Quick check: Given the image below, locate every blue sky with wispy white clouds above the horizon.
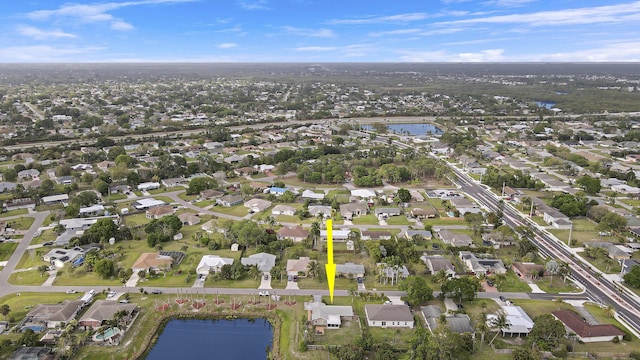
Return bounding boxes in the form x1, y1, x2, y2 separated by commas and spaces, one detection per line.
0, 0, 640, 62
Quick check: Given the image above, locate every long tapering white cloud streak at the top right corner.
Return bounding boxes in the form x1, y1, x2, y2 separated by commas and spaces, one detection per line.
440, 2, 640, 26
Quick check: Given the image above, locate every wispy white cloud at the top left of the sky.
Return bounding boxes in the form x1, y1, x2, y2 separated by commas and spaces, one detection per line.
25, 0, 195, 30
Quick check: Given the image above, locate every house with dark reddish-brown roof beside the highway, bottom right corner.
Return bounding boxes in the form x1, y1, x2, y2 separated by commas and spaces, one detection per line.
551, 310, 624, 342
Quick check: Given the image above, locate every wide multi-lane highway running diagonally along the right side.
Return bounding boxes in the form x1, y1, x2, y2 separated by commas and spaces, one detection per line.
449, 164, 640, 334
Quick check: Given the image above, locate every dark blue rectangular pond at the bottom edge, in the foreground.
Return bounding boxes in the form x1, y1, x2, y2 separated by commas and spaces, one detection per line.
147, 319, 273, 360
